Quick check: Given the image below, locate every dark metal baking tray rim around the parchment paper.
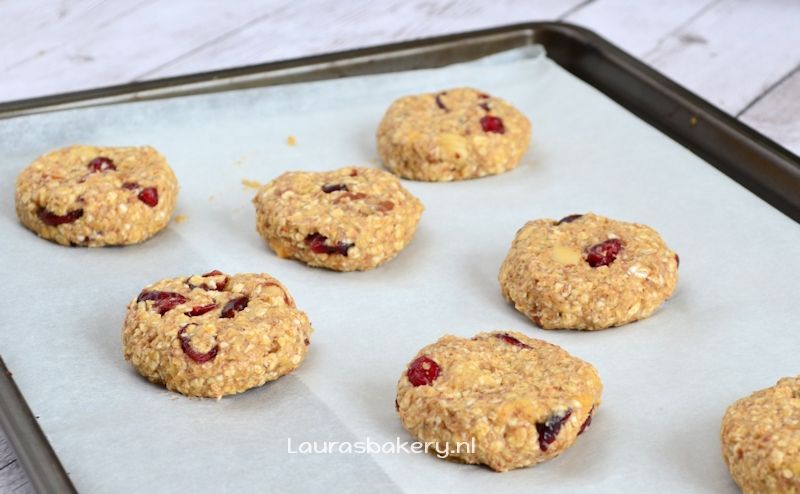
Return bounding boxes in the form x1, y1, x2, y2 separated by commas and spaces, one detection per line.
0, 23, 800, 492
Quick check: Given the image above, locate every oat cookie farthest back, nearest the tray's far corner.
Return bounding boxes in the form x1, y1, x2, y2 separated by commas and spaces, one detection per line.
378, 88, 531, 182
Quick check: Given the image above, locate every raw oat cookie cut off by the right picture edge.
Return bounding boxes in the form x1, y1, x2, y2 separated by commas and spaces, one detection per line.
721, 376, 800, 494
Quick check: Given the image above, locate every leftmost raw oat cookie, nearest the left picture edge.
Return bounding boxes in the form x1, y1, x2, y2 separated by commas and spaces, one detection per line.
15, 146, 178, 247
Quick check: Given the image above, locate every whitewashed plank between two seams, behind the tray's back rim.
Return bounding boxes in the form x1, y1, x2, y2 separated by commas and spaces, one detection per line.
140, 0, 581, 78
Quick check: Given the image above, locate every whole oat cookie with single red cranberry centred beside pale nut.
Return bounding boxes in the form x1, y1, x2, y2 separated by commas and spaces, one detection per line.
500, 213, 680, 330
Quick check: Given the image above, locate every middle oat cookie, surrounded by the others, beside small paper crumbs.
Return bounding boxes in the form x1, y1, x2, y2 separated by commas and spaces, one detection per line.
253, 167, 424, 271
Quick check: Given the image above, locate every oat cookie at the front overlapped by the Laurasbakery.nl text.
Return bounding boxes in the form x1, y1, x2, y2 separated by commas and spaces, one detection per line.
396, 331, 603, 472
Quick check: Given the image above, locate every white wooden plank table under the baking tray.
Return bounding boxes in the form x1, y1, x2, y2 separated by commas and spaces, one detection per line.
0, 0, 800, 493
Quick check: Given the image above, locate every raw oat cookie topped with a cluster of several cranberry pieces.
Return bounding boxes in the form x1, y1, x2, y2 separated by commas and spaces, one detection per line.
122, 271, 312, 398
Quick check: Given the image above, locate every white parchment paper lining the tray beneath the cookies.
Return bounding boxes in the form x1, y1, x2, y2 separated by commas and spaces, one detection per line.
0, 45, 800, 493
